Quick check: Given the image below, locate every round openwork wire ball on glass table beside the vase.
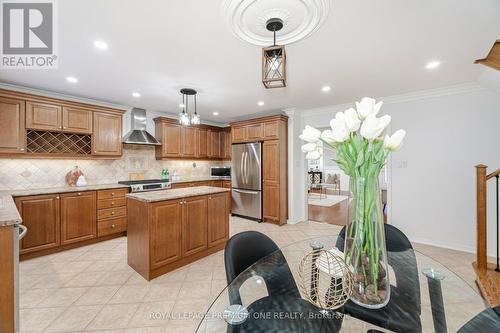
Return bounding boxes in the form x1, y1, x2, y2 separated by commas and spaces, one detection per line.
299, 249, 354, 309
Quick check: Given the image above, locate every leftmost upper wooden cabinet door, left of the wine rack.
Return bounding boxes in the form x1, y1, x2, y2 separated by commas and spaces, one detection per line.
0, 97, 26, 154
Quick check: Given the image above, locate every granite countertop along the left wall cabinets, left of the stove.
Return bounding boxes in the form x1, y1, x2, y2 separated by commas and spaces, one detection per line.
0, 183, 129, 227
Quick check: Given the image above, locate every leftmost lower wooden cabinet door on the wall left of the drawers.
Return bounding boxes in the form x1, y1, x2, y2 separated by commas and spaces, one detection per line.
15, 194, 61, 254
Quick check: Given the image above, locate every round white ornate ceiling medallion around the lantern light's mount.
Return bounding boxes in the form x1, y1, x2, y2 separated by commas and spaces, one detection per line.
222, 0, 331, 46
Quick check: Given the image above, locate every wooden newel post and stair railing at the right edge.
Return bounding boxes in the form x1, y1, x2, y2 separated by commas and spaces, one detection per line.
476, 164, 500, 272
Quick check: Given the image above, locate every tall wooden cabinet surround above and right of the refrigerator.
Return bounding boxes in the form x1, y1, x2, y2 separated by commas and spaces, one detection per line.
230, 115, 288, 225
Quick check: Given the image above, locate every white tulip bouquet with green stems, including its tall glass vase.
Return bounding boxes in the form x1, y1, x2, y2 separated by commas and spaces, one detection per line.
300, 97, 406, 308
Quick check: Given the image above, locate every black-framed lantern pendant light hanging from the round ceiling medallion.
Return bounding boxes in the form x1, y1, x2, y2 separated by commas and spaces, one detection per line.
262, 18, 286, 89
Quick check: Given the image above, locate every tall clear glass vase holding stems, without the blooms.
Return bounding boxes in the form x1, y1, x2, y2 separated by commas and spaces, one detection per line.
344, 174, 390, 309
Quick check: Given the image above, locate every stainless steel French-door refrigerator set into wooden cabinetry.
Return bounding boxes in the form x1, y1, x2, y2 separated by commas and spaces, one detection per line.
231, 142, 262, 222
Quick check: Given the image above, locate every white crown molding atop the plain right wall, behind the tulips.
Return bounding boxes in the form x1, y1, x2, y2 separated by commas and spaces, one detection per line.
300, 82, 487, 118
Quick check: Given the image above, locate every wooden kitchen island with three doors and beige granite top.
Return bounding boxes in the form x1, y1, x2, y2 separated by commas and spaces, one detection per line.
127, 186, 231, 281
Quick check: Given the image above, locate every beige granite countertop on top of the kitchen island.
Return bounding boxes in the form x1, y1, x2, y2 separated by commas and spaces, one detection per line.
127, 186, 230, 202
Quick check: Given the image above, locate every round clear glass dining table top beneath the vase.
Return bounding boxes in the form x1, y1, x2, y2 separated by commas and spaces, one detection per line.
196, 235, 486, 333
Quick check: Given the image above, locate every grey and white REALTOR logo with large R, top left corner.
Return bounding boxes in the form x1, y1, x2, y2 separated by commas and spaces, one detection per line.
0, 0, 57, 69
